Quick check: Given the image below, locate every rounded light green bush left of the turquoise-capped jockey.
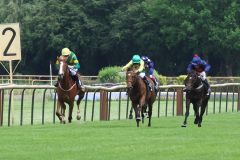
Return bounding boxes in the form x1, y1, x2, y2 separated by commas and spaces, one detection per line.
98, 66, 126, 83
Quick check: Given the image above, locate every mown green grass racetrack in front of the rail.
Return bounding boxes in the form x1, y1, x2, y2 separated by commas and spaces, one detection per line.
0, 112, 240, 160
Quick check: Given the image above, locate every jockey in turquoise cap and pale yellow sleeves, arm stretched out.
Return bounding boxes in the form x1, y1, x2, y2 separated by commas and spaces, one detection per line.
122, 55, 152, 90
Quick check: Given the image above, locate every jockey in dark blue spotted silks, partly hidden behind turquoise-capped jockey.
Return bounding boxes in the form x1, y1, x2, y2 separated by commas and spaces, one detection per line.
141, 56, 158, 89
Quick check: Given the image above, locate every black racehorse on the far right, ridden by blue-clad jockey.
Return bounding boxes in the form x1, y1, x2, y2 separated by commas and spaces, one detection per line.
182, 71, 210, 127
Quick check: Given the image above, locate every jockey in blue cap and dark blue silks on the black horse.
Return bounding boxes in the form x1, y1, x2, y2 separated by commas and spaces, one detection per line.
187, 54, 211, 95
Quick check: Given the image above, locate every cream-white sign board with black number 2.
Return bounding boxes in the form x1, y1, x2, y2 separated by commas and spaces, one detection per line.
0, 23, 21, 61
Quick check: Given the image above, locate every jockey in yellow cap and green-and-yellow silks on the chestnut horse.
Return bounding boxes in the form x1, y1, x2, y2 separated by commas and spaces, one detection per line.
55, 48, 84, 89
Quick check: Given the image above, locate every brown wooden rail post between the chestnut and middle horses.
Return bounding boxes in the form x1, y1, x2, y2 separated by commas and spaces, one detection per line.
100, 90, 108, 121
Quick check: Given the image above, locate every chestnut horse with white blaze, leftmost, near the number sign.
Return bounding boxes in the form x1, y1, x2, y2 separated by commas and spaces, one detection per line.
56, 56, 85, 123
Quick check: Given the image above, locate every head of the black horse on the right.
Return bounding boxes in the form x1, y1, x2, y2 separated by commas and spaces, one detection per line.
184, 71, 201, 91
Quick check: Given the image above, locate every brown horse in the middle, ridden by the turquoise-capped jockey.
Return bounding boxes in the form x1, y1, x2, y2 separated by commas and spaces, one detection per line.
126, 70, 156, 127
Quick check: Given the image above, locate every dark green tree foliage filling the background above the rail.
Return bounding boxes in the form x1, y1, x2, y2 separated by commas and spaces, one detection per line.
0, 0, 240, 76
